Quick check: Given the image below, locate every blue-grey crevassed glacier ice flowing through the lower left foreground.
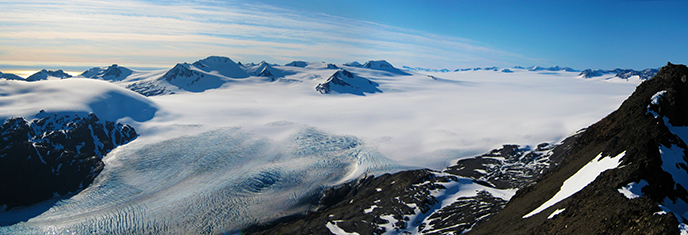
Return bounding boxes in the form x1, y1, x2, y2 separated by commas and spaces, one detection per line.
0, 127, 399, 234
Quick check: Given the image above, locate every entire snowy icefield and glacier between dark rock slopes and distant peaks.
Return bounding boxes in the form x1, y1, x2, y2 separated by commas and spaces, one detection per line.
0, 63, 640, 234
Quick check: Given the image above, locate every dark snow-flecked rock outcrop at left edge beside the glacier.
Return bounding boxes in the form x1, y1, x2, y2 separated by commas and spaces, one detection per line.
0, 112, 137, 208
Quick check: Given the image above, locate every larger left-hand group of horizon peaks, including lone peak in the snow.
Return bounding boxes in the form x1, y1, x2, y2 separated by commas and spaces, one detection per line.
0, 56, 410, 96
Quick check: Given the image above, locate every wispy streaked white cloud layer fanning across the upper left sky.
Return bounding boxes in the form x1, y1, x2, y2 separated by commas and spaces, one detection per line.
0, 0, 530, 68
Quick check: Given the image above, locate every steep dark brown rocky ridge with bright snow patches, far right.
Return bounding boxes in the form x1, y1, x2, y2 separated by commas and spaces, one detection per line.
470, 64, 688, 234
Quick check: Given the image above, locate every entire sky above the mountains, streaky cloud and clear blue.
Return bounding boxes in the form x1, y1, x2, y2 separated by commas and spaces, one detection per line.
0, 0, 688, 72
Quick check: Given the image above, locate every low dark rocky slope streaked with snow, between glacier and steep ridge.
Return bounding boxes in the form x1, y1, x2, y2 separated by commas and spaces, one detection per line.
248, 134, 579, 234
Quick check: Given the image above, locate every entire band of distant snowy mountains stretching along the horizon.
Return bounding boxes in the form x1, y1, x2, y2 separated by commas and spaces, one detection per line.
0, 56, 658, 91
